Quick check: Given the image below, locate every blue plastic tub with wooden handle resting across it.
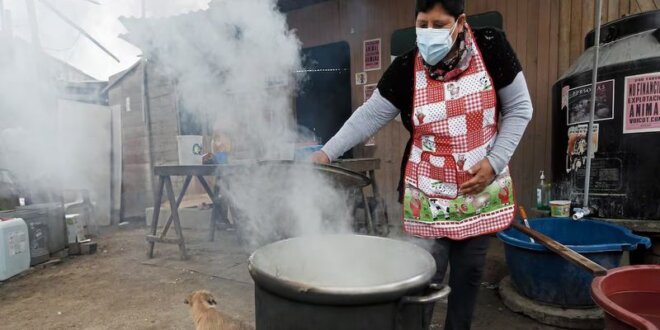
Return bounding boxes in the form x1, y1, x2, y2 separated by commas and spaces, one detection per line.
497, 218, 651, 307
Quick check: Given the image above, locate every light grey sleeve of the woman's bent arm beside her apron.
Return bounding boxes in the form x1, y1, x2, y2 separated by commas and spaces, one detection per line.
487, 71, 533, 174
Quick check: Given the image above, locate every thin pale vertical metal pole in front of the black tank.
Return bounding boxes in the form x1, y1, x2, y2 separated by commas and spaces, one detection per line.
584, 0, 600, 209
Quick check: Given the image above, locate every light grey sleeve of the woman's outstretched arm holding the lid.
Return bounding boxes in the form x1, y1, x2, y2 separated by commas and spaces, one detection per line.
321, 89, 399, 161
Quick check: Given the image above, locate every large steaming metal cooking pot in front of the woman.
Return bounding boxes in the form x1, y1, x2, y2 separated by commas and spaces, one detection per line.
249, 235, 449, 330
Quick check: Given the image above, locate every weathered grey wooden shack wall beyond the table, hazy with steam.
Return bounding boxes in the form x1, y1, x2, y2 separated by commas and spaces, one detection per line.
108, 63, 182, 219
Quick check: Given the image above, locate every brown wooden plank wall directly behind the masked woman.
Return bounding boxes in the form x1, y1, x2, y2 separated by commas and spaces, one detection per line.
288, 0, 660, 222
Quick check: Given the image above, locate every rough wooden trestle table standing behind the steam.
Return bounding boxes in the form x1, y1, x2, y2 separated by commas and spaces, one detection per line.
146, 158, 387, 259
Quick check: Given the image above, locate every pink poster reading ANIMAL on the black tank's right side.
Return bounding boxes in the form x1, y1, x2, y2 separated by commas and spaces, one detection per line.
623, 72, 660, 134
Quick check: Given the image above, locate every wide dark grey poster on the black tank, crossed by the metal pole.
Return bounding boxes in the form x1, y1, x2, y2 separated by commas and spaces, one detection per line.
566, 79, 614, 125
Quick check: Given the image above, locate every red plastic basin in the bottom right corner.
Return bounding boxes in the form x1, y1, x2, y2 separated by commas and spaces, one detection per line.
591, 265, 660, 330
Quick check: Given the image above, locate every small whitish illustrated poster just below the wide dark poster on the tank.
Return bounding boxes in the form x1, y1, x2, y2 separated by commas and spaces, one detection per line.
566, 124, 599, 173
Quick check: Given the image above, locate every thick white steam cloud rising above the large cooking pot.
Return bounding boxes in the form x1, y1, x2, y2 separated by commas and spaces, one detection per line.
126, 0, 358, 248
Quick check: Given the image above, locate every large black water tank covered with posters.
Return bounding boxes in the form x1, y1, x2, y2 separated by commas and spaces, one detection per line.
552, 10, 660, 221
